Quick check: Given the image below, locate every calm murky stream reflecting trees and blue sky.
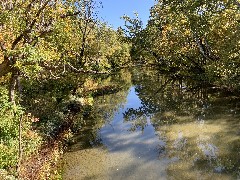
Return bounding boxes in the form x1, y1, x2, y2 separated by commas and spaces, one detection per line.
63, 68, 240, 180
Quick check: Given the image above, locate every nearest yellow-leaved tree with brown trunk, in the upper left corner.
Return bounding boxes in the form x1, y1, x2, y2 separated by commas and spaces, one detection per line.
0, 0, 86, 102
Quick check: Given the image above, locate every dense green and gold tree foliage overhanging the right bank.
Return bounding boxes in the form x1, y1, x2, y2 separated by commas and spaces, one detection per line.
127, 0, 240, 88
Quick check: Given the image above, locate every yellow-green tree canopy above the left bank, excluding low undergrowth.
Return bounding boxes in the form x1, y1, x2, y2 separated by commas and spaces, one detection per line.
0, 0, 129, 81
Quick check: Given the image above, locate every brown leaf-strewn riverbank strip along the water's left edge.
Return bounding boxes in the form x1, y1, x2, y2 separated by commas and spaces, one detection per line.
16, 84, 128, 180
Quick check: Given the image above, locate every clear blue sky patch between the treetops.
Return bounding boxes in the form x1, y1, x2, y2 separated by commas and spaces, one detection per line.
98, 0, 154, 29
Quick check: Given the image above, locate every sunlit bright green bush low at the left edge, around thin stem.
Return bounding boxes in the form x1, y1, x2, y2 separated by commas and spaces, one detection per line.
0, 87, 41, 172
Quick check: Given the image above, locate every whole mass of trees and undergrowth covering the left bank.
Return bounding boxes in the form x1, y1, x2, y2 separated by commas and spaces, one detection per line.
0, 0, 130, 177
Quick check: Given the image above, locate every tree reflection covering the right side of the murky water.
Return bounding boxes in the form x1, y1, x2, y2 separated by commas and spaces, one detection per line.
124, 67, 240, 179
